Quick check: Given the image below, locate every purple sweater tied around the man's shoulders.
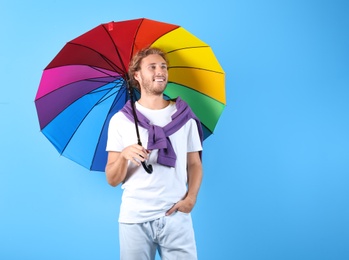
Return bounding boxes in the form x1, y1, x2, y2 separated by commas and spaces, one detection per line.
120, 97, 203, 167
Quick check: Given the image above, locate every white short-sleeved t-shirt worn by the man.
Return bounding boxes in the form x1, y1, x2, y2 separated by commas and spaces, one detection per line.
106, 102, 202, 223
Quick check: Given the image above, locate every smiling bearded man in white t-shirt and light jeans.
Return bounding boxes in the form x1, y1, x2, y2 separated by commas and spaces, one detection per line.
105, 48, 202, 260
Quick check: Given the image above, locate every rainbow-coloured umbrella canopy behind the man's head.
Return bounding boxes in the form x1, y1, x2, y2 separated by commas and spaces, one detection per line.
35, 18, 225, 171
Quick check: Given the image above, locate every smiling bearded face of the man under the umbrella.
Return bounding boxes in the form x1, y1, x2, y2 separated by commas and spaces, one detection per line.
135, 54, 168, 95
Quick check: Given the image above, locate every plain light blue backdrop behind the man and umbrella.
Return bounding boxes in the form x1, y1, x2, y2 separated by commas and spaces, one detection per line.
0, 0, 349, 260
